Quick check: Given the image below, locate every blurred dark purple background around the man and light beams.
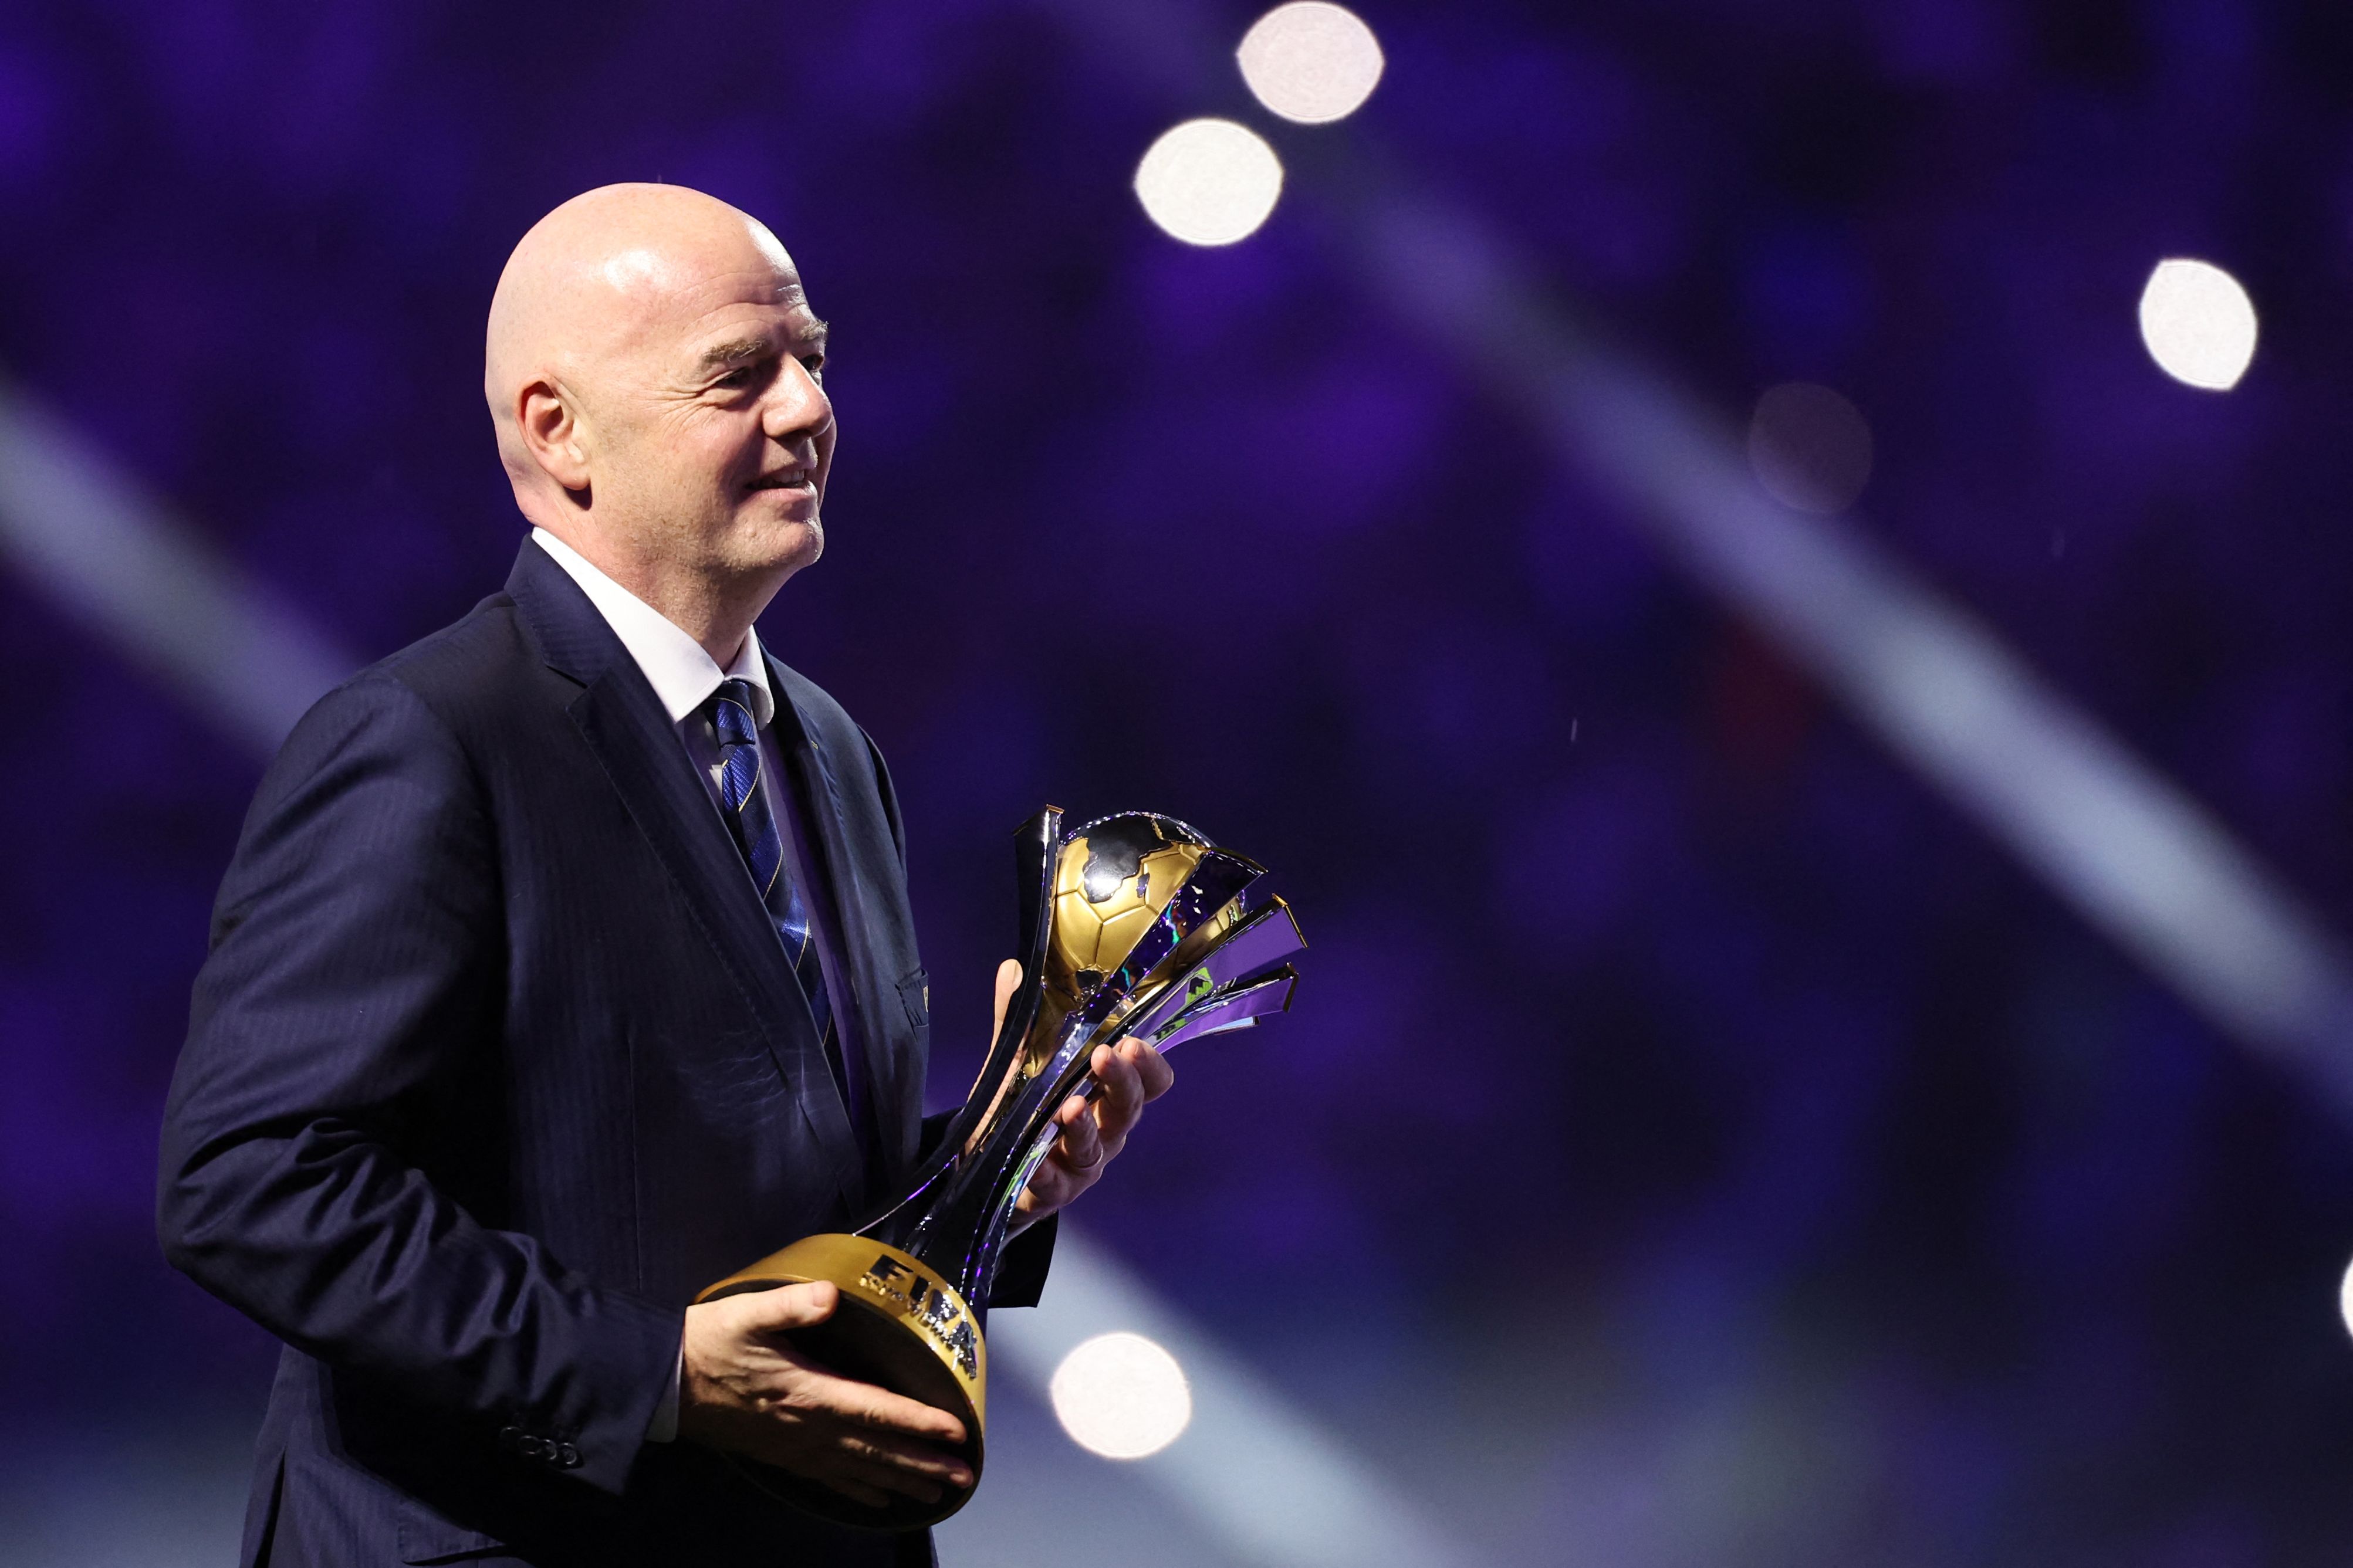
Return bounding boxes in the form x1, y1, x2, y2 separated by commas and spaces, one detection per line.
0, 0, 2353, 1568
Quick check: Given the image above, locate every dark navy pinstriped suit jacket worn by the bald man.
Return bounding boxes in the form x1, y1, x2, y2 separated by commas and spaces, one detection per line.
158, 543, 1052, 1568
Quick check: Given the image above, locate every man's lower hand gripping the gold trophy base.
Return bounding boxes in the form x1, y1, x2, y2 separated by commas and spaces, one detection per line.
678, 1281, 972, 1507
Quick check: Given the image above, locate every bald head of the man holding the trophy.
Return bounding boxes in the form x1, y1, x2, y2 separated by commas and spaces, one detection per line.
482, 186, 833, 663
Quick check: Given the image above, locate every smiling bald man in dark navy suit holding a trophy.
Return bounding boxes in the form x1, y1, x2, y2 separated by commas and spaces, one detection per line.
160, 186, 1169, 1568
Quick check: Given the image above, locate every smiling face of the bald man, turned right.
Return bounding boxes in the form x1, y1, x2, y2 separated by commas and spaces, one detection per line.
583, 231, 833, 594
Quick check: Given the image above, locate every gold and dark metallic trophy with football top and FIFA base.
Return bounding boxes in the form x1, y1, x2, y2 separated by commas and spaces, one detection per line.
697, 807, 1306, 1530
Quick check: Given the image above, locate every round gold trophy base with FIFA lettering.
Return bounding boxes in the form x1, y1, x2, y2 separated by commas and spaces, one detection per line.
694, 1234, 988, 1530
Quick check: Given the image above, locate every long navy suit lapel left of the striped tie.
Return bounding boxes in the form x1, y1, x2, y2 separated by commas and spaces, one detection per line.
506, 543, 864, 1206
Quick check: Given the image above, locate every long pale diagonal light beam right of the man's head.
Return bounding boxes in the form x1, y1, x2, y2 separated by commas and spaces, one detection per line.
1341, 181, 2353, 1105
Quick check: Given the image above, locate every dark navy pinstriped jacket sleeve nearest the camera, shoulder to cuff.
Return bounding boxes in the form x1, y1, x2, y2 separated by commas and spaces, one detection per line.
158, 675, 682, 1491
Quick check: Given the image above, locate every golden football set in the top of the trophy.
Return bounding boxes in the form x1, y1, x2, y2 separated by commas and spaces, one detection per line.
1044, 811, 1209, 1001
